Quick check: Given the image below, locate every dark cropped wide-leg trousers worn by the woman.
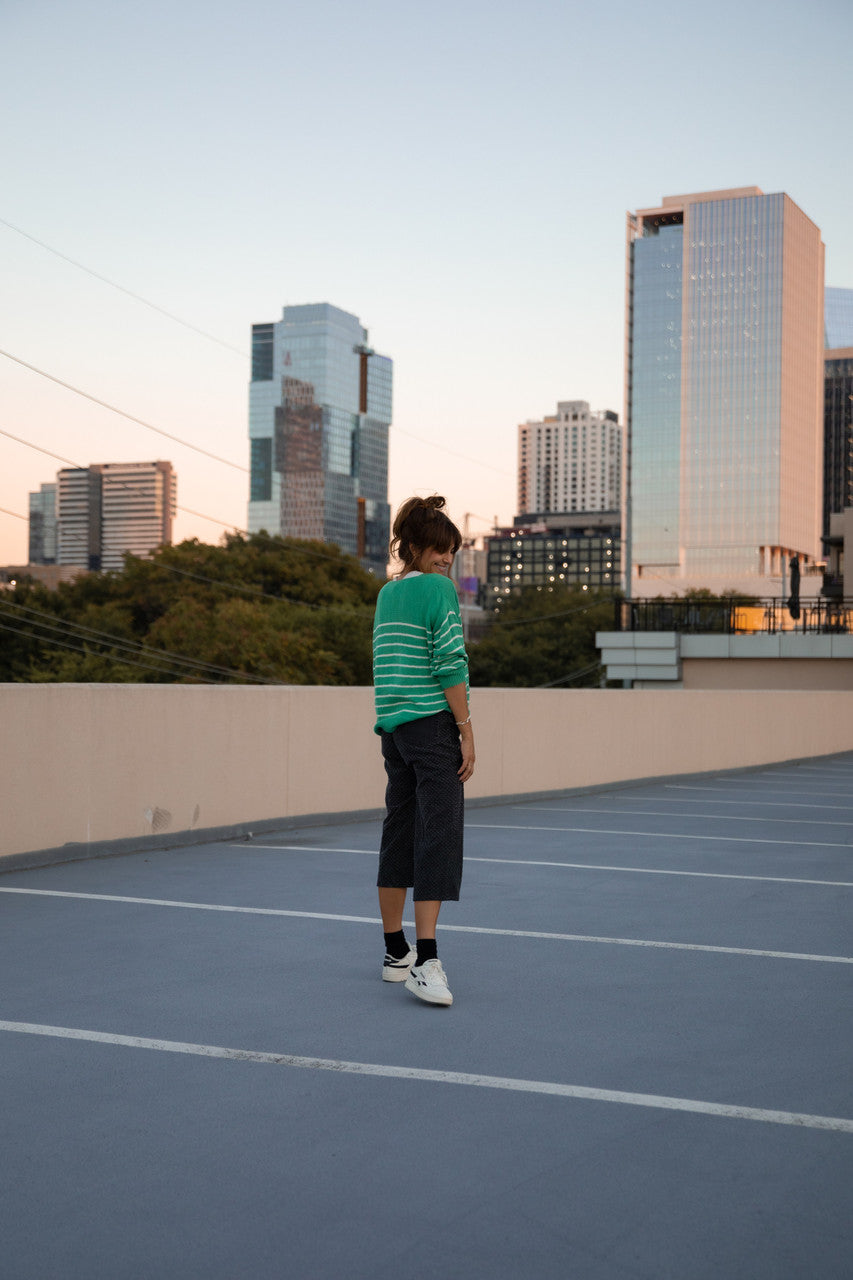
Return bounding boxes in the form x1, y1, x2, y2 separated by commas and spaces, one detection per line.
377, 712, 465, 902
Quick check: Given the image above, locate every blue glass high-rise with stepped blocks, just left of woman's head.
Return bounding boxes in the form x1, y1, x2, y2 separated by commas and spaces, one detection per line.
248, 303, 392, 576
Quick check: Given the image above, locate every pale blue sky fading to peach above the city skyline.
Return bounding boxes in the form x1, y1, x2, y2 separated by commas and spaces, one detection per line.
0, 0, 853, 564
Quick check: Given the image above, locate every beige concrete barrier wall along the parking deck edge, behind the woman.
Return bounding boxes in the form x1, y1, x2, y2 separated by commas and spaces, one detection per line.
0, 685, 853, 858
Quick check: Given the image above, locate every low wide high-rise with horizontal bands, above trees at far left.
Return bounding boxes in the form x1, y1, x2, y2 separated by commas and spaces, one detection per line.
56, 462, 177, 570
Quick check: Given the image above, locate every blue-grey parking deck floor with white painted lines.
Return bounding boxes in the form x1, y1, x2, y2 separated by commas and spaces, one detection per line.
0, 754, 853, 1280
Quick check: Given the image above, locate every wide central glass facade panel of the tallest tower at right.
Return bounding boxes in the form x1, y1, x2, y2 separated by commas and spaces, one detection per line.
681, 196, 783, 573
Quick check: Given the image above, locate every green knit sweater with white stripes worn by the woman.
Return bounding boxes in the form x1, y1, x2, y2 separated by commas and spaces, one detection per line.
373, 573, 467, 733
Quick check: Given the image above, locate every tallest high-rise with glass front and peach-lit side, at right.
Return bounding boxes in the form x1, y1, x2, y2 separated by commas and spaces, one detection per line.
626, 187, 824, 594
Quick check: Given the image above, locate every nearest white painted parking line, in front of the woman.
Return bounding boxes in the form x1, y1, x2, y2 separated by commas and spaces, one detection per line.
0, 1021, 853, 1133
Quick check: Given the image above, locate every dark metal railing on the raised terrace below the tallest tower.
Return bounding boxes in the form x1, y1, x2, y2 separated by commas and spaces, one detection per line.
613, 596, 853, 635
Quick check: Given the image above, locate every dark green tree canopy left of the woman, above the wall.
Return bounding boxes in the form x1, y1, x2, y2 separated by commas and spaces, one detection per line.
0, 534, 382, 685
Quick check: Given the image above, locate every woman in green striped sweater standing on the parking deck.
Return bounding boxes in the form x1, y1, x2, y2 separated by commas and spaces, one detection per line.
373, 497, 474, 1005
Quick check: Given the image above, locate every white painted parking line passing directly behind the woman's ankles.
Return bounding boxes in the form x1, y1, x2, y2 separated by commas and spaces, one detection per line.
0, 888, 853, 964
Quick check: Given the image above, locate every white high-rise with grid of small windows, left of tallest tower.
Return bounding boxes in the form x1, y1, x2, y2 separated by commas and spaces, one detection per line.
519, 401, 622, 516
